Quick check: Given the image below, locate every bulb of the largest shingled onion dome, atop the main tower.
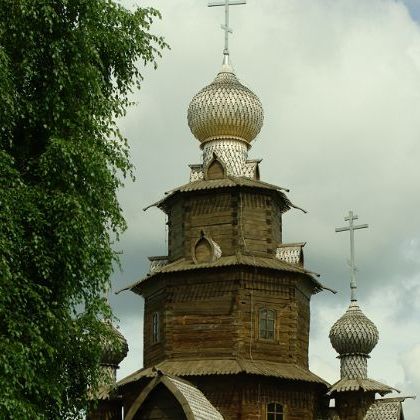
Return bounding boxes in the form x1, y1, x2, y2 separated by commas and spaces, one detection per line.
188, 62, 264, 144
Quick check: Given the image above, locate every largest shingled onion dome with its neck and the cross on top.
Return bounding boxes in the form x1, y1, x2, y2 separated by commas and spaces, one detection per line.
187, 0, 264, 179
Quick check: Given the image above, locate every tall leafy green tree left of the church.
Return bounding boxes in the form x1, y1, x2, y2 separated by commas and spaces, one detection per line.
0, 0, 167, 419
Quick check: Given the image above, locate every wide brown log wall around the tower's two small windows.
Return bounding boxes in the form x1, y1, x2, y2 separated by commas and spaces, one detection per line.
144, 267, 309, 368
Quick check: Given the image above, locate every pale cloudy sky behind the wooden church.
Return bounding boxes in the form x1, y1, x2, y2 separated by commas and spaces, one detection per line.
111, 0, 420, 419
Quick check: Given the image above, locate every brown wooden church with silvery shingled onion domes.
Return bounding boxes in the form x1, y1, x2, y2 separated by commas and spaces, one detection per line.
88, 1, 412, 420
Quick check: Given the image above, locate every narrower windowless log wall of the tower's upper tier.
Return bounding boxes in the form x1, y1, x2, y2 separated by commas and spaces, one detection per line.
168, 188, 282, 261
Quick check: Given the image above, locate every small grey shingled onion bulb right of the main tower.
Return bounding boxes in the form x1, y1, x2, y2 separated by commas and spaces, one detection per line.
330, 302, 379, 355
